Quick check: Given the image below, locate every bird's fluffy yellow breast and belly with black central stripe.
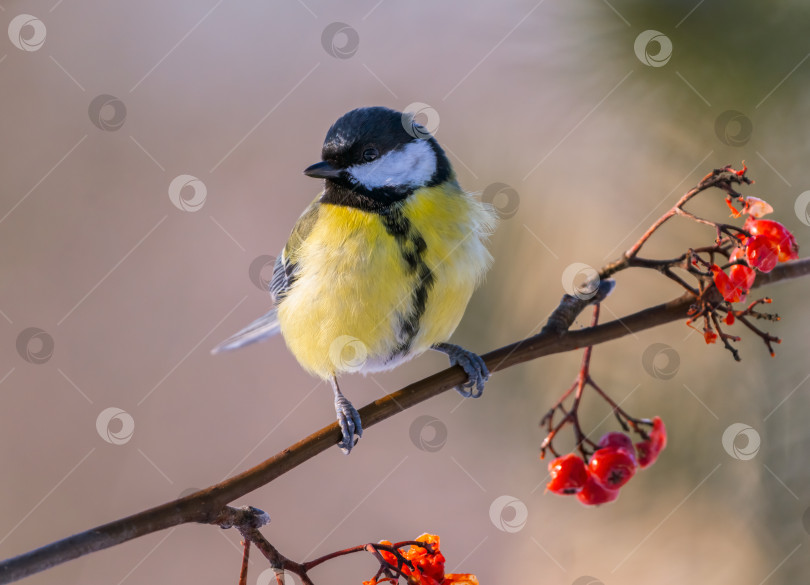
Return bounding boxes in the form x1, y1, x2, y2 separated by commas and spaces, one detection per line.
278, 184, 494, 378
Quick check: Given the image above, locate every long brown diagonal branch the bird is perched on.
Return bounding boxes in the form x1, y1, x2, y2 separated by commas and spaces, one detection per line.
0, 258, 810, 583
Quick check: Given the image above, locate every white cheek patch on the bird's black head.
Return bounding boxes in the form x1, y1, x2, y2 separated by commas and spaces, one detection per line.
348, 140, 436, 189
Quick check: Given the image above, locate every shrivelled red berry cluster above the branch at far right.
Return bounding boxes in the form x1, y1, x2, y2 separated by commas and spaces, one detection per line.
707, 197, 799, 306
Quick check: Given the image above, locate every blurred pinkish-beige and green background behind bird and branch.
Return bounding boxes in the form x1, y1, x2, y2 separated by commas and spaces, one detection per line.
0, 0, 810, 585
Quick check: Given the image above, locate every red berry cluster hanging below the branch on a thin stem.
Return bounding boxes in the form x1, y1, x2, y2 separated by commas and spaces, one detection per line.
546, 416, 667, 506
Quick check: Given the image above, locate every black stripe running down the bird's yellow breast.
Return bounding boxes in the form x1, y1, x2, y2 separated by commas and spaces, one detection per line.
381, 207, 435, 358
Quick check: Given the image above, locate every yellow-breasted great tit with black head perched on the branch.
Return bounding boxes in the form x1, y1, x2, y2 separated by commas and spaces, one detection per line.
213, 107, 496, 453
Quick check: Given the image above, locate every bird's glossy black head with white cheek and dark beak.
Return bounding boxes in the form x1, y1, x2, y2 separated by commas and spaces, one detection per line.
304, 107, 452, 211
